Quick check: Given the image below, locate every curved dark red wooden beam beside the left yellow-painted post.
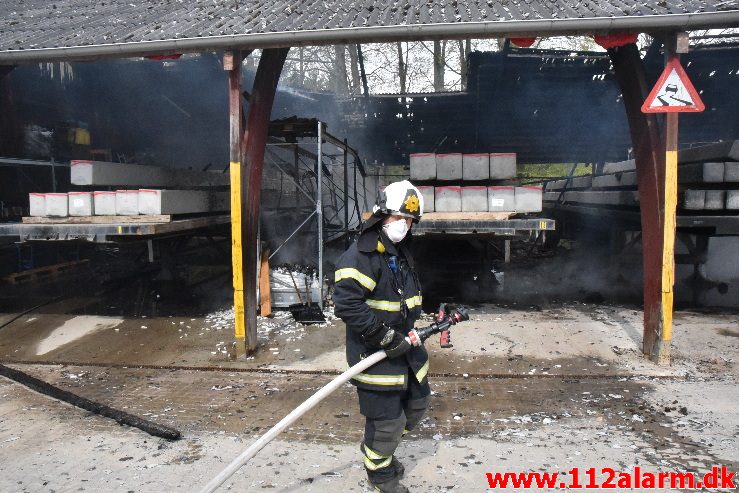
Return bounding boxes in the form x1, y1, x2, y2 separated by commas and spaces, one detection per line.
241, 48, 289, 353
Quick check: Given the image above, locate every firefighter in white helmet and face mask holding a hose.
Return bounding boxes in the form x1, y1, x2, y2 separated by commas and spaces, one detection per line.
334, 180, 424, 493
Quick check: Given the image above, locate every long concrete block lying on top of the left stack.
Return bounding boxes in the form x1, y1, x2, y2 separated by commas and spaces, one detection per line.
70, 161, 229, 187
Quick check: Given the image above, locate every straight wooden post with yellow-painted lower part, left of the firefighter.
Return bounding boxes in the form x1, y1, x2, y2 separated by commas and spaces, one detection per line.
223, 51, 246, 340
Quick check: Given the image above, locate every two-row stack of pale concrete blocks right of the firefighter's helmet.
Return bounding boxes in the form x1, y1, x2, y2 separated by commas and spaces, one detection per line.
410, 153, 542, 213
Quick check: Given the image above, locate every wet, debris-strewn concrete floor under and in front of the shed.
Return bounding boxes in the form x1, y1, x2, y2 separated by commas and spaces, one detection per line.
0, 258, 739, 492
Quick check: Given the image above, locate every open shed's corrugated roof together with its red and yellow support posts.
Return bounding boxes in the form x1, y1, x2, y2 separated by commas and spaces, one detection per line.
0, 0, 739, 362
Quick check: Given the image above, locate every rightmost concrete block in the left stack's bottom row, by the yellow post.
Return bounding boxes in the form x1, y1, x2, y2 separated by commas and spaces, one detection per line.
138, 188, 230, 214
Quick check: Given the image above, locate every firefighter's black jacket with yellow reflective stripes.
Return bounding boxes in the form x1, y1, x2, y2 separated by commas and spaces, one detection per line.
334, 226, 429, 390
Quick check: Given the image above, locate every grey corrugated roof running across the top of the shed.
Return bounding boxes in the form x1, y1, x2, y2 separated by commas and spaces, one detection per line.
0, 0, 739, 59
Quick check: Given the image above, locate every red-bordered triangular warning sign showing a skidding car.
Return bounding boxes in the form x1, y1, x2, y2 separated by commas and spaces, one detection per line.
641, 57, 706, 113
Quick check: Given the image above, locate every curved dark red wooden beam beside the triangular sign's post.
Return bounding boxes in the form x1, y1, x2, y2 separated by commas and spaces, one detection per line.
608, 44, 672, 362
